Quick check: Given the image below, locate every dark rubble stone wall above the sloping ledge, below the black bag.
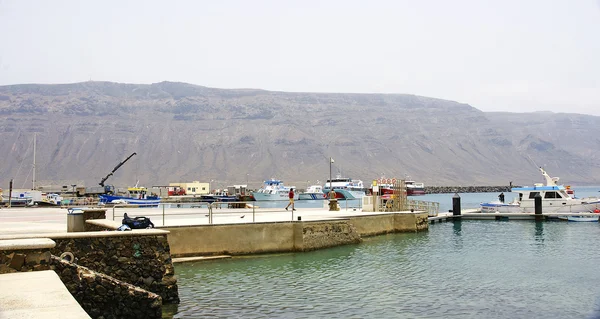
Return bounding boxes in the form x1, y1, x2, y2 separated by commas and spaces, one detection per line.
51, 232, 179, 303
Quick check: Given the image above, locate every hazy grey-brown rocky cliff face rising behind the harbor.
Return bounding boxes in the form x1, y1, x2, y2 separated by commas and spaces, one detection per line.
0, 82, 600, 188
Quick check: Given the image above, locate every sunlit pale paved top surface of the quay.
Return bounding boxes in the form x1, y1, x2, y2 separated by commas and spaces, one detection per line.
0, 205, 422, 239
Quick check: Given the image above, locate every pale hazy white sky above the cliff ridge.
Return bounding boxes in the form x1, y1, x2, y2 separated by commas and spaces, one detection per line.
0, 0, 600, 115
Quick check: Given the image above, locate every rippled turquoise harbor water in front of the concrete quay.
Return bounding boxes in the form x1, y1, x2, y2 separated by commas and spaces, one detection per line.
164, 221, 600, 318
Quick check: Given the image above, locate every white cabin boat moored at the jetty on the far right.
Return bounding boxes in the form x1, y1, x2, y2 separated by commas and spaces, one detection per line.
480, 167, 600, 213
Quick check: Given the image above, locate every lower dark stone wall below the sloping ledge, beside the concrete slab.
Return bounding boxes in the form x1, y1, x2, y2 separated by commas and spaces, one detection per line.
51, 256, 162, 319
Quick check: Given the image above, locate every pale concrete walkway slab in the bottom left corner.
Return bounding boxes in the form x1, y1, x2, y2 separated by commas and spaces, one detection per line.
0, 270, 90, 319
